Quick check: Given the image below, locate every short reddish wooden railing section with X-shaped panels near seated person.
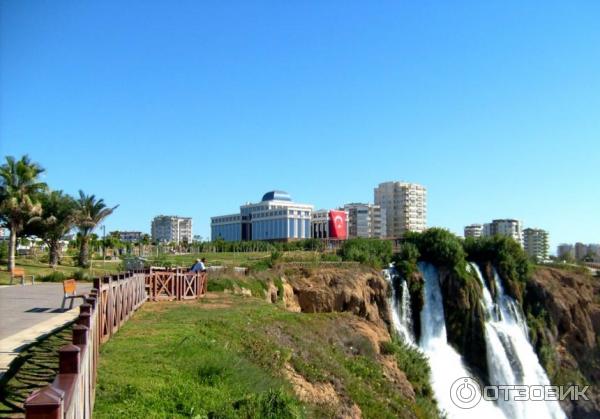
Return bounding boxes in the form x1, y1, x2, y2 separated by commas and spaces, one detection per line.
146, 268, 207, 301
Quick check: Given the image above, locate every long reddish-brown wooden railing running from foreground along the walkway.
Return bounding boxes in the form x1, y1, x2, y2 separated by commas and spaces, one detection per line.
25, 272, 147, 419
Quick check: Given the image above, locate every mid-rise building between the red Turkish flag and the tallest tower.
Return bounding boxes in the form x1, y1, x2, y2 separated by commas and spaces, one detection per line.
344, 203, 387, 238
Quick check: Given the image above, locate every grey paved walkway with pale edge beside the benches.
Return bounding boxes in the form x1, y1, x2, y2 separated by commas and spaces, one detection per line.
0, 283, 92, 377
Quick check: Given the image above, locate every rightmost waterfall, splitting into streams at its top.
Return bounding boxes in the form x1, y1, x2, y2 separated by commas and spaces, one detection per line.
471, 263, 566, 419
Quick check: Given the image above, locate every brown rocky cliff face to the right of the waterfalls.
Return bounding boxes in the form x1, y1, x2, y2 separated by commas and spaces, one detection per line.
524, 268, 600, 418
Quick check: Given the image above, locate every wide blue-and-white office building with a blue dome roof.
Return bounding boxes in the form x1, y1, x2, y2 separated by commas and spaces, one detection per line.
211, 191, 313, 241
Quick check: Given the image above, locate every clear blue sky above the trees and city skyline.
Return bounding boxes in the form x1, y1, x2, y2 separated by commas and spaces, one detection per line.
0, 0, 600, 251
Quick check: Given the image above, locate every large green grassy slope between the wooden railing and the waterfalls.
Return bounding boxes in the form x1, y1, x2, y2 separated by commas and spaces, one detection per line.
94, 293, 429, 418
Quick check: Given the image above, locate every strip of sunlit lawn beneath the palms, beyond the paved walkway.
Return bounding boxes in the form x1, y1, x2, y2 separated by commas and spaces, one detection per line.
0, 257, 121, 285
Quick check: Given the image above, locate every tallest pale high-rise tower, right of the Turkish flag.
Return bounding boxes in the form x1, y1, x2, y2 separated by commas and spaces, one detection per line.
374, 182, 427, 237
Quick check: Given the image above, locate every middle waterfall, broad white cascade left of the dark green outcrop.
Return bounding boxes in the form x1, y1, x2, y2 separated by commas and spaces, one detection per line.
419, 262, 505, 419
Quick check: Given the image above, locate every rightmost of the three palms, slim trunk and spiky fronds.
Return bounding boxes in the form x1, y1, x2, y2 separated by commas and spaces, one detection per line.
76, 191, 118, 268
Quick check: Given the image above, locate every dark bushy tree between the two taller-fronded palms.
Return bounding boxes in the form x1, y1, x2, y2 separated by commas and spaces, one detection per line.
26, 191, 77, 268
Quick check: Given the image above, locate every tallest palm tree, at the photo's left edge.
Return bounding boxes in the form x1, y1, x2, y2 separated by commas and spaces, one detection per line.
0, 155, 46, 271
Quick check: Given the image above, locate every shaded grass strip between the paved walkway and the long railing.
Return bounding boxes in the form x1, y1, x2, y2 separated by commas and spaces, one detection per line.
0, 326, 72, 418
